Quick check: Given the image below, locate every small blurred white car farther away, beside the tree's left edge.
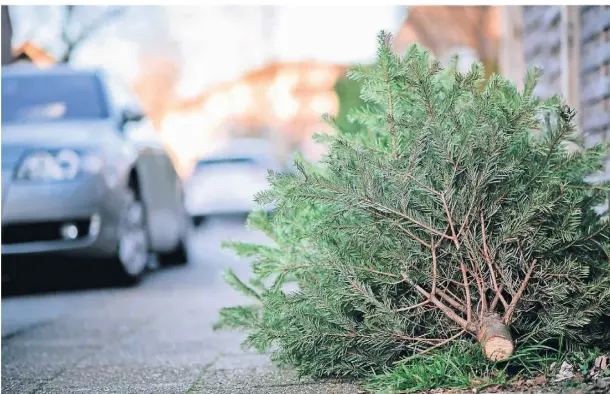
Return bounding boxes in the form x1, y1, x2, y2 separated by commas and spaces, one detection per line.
185, 139, 280, 225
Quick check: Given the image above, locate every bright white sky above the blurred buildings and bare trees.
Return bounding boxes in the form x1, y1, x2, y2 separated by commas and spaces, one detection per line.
10, 6, 406, 97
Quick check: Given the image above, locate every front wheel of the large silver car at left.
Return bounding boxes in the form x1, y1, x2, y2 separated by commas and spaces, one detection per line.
111, 188, 150, 286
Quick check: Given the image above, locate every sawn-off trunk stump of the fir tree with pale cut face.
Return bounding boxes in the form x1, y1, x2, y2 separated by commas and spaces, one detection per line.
477, 314, 515, 361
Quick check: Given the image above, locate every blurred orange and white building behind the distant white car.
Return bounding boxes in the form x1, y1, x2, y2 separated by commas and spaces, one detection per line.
161, 62, 346, 174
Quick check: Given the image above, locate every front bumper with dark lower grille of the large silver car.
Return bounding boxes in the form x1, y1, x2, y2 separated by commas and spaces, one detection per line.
2, 176, 121, 257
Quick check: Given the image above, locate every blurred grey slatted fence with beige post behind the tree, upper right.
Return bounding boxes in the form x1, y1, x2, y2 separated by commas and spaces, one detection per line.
501, 6, 610, 145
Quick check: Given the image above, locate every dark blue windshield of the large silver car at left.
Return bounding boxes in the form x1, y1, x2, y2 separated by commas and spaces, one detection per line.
2, 74, 108, 123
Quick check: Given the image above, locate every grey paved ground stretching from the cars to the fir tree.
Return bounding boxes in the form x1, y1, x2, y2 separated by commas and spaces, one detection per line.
2, 218, 264, 394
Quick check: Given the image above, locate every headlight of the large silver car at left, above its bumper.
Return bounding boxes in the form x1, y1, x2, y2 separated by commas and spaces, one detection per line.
15, 149, 103, 180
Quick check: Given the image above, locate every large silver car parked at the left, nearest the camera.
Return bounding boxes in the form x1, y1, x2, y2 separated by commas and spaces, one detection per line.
2, 65, 190, 284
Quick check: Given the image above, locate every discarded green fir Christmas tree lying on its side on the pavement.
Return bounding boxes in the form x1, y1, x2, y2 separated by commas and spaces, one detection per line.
217, 34, 610, 376
